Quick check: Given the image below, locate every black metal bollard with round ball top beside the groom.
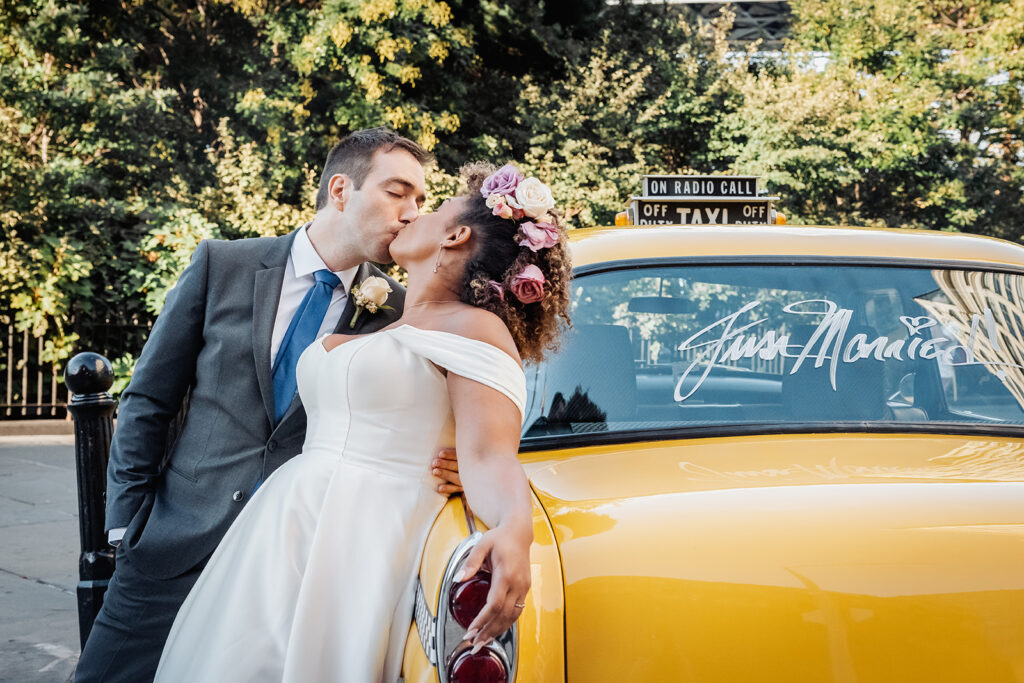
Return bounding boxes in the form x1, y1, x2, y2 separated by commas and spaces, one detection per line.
65, 351, 117, 647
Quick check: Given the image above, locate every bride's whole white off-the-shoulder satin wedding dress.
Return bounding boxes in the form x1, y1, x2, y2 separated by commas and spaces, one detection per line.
157, 325, 526, 683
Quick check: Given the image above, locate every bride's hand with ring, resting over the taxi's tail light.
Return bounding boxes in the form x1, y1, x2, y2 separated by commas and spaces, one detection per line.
456, 524, 534, 651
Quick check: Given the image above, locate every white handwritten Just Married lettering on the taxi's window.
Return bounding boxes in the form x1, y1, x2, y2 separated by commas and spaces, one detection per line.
674, 299, 1024, 401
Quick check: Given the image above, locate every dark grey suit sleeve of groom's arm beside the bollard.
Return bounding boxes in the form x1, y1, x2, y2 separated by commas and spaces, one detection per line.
106, 241, 210, 530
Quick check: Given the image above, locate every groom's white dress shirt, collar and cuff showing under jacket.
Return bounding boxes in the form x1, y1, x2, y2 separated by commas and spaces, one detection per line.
106, 223, 359, 546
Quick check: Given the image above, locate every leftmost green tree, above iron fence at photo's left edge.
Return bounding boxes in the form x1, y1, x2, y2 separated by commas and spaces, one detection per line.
0, 2, 189, 358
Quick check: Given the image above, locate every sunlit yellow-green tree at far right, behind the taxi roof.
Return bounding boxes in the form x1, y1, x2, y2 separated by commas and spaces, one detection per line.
715, 0, 1024, 235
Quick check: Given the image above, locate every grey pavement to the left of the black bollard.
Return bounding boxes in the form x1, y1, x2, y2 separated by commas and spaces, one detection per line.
0, 436, 79, 683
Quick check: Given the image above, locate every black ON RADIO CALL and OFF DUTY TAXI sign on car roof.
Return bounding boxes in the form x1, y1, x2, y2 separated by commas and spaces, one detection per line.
630, 175, 778, 225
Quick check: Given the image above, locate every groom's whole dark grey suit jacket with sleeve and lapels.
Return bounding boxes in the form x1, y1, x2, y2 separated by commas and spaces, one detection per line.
106, 232, 404, 579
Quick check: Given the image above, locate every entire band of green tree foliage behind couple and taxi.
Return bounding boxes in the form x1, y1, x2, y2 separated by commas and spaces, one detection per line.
0, 0, 1024, 374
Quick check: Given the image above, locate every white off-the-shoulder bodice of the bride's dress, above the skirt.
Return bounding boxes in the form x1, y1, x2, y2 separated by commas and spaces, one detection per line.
297, 325, 526, 478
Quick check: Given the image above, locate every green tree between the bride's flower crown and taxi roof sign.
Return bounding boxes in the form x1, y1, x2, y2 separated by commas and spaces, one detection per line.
515, 4, 733, 227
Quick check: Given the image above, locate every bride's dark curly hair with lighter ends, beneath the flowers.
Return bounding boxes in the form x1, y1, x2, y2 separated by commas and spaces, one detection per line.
458, 162, 571, 361
